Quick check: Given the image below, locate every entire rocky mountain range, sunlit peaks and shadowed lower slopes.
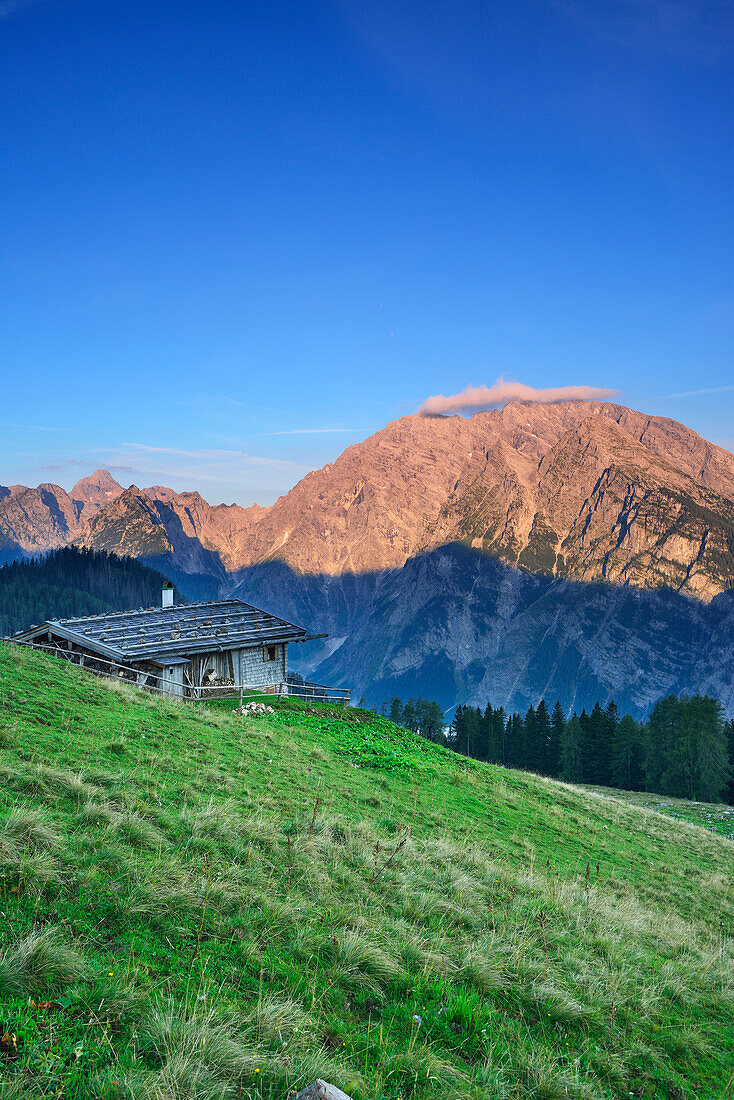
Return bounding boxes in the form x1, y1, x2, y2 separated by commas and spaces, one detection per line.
0, 402, 734, 715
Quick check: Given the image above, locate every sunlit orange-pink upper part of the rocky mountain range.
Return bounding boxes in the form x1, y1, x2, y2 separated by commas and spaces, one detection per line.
0, 402, 734, 601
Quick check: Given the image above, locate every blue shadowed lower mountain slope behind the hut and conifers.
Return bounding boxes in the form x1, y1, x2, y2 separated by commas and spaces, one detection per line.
237, 545, 734, 717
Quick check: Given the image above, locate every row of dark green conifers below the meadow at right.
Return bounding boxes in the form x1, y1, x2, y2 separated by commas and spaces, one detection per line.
383, 695, 734, 804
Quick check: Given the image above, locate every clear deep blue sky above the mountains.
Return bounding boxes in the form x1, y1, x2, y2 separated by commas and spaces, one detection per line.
0, 0, 734, 504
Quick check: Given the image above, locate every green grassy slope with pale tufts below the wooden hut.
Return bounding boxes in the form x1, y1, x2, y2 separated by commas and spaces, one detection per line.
0, 646, 734, 1100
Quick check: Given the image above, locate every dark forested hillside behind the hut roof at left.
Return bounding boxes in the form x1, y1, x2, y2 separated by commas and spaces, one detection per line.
0, 547, 180, 638
